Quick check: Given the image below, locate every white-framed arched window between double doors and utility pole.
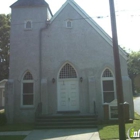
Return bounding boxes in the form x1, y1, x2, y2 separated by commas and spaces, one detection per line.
101, 68, 115, 103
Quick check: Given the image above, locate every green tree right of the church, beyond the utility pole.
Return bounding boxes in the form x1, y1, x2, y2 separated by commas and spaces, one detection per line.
127, 51, 140, 94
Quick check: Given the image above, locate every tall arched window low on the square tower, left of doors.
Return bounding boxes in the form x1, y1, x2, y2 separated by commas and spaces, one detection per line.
22, 72, 34, 106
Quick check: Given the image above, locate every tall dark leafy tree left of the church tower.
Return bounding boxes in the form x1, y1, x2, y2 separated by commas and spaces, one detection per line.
0, 14, 11, 80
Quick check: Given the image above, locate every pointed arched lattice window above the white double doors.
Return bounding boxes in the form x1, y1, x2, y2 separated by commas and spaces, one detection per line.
59, 63, 77, 79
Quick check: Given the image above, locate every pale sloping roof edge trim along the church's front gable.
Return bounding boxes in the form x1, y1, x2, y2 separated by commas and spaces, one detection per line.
51, 0, 127, 60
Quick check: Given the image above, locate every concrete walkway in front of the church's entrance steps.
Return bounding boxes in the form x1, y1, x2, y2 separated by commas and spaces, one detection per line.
24, 129, 100, 140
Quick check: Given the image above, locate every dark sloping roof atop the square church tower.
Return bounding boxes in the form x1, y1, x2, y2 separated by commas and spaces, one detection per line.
10, 0, 48, 8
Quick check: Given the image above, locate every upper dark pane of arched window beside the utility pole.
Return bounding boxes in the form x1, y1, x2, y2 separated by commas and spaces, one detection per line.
103, 80, 114, 91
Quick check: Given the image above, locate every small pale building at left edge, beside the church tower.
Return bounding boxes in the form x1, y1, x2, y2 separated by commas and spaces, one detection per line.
0, 79, 7, 109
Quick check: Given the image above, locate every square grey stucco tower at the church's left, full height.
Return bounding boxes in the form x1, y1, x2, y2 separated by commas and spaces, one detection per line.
7, 0, 52, 122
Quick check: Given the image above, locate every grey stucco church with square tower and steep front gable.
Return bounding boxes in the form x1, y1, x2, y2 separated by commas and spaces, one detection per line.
6, 0, 133, 122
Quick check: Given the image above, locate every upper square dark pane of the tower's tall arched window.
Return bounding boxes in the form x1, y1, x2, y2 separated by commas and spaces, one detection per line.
23, 83, 33, 94
